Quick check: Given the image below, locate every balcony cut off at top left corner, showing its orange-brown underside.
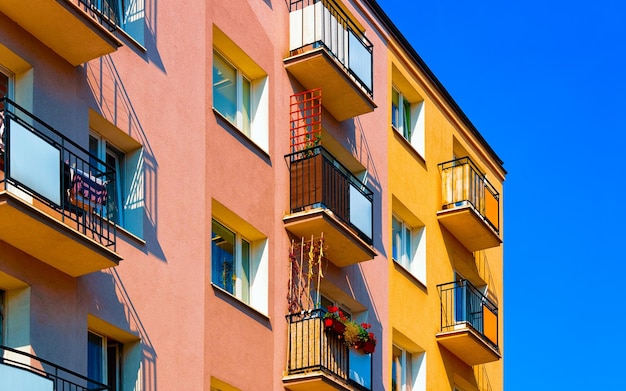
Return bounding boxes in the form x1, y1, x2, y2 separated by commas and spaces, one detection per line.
0, 0, 122, 66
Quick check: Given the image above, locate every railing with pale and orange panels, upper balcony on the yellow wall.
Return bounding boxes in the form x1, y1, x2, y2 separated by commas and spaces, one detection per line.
439, 157, 500, 232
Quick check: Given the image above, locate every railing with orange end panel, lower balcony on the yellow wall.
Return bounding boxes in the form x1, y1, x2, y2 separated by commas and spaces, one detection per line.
437, 280, 498, 350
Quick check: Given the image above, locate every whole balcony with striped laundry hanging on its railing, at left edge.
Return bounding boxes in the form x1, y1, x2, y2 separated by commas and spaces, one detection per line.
0, 99, 122, 277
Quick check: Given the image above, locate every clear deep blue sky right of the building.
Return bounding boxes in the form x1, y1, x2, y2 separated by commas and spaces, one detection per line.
379, 0, 626, 391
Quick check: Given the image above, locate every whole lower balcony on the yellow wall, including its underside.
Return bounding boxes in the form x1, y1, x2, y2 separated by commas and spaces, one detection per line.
437, 280, 502, 365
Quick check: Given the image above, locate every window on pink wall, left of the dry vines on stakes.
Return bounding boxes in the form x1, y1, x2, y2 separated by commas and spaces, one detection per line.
211, 214, 268, 313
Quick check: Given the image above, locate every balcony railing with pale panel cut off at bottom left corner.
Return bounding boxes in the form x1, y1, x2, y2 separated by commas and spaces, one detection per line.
0, 346, 111, 391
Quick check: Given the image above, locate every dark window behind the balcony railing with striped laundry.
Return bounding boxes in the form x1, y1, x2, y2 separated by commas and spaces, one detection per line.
89, 134, 125, 227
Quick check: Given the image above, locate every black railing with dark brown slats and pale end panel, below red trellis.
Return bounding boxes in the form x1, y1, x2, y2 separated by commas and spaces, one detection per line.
285, 146, 374, 244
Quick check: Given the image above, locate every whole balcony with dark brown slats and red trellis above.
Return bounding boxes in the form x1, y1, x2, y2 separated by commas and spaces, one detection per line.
283, 146, 376, 267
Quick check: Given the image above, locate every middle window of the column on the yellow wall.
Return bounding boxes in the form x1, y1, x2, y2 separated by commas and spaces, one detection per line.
391, 215, 426, 283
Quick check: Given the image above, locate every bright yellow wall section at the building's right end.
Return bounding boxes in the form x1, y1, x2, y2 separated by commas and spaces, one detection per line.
379, 42, 505, 391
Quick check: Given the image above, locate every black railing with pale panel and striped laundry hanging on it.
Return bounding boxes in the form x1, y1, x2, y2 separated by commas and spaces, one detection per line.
0, 98, 119, 251
